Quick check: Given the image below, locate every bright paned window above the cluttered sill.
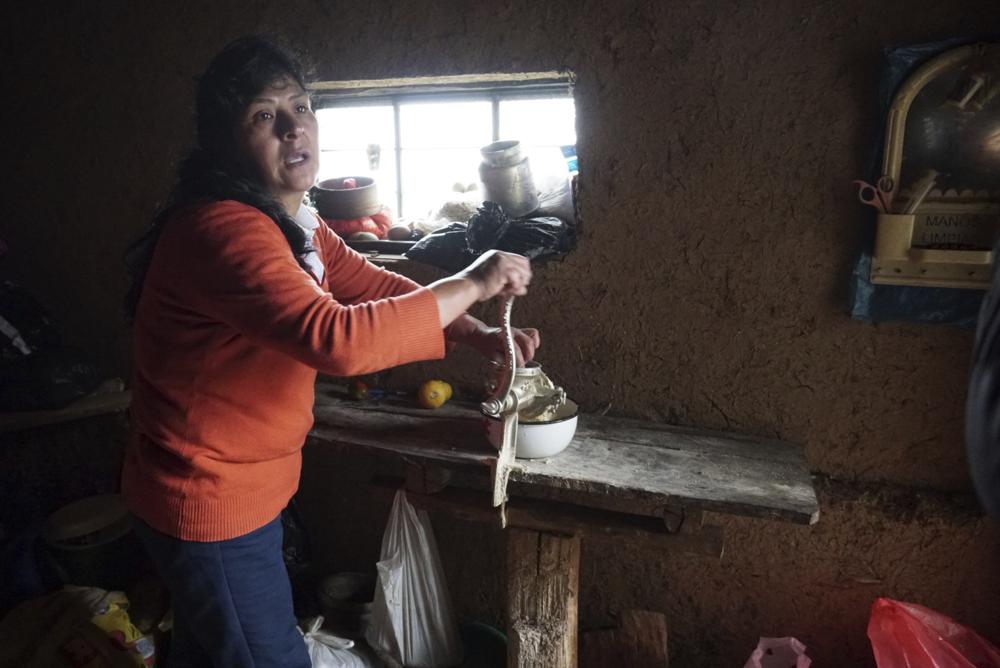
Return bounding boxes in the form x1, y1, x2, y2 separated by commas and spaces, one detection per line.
314, 72, 576, 220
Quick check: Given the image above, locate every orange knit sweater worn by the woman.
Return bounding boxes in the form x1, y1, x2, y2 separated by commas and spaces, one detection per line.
122, 201, 445, 541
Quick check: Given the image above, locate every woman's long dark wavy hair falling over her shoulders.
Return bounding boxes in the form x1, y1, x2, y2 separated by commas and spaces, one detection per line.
125, 35, 307, 321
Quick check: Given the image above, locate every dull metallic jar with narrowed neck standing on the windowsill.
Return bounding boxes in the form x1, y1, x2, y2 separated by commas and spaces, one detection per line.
479, 140, 538, 218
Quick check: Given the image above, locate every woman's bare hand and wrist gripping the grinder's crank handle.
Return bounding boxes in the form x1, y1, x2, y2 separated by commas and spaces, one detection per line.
427, 250, 531, 327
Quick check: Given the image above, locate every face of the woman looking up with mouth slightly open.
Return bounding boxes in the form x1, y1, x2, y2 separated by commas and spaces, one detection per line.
236, 79, 319, 216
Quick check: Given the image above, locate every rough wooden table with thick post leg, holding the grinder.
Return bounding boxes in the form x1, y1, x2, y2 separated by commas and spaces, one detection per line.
310, 384, 819, 668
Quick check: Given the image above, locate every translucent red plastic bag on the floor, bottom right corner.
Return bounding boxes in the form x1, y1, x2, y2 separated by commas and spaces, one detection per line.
868, 598, 1000, 668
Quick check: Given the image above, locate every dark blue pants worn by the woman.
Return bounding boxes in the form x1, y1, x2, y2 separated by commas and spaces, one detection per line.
135, 516, 310, 668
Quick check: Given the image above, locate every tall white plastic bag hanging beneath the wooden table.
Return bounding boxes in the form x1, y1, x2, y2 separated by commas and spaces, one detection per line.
365, 490, 462, 668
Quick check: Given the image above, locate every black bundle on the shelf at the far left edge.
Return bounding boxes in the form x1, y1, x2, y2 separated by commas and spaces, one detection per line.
0, 282, 103, 411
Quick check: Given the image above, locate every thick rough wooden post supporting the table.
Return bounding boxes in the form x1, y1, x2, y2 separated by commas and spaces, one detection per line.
507, 528, 580, 668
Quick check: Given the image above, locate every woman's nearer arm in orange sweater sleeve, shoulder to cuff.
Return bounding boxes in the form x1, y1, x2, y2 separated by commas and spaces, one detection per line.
158, 202, 445, 376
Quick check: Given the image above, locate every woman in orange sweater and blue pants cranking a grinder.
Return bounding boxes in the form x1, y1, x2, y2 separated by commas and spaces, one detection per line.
122, 37, 539, 668
